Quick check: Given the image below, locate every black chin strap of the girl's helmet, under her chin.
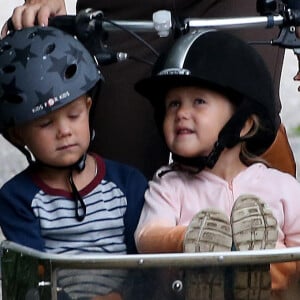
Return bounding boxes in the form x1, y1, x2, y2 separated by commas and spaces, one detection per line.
172, 101, 252, 172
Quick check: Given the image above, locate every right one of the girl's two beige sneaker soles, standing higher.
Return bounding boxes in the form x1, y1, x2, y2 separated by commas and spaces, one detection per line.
231, 195, 278, 300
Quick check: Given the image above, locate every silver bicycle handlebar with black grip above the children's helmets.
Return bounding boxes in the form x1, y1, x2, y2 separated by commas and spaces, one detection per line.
49, 9, 300, 48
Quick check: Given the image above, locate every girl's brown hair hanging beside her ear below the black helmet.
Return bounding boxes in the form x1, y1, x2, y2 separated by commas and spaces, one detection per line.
240, 114, 269, 167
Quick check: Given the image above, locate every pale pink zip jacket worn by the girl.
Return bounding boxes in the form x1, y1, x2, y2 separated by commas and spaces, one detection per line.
135, 163, 300, 248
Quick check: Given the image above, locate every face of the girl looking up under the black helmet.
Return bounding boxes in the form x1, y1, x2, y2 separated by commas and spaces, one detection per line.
163, 86, 235, 157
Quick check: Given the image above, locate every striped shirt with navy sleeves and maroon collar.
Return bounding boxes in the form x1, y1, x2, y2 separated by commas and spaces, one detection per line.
0, 154, 147, 298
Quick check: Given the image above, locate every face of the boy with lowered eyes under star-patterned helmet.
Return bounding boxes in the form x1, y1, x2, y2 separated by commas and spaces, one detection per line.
12, 95, 92, 166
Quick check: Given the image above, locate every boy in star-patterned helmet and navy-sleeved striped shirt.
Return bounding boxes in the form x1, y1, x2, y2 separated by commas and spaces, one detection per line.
0, 27, 147, 299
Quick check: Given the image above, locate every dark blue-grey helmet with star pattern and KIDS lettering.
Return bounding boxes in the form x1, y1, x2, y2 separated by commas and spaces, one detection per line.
0, 27, 103, 130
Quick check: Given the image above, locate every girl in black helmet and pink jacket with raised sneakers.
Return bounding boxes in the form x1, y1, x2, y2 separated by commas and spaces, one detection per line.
135, 31, 300, 299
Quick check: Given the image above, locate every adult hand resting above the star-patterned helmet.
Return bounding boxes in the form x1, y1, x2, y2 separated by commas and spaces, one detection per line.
1, 0, 67, 38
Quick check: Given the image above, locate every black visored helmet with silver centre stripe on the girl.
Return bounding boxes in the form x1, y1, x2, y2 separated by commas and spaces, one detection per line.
135, 30, 280, 169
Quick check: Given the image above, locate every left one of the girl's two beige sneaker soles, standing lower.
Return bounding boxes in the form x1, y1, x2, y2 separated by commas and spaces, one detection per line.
184, 210, 232, 300
